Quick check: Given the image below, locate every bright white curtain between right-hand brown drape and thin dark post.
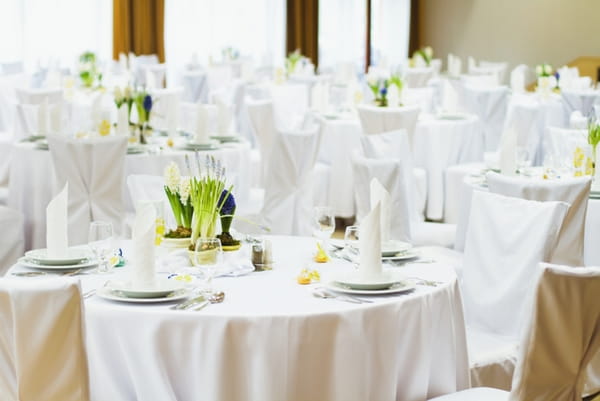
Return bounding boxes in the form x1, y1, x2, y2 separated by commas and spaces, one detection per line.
319, 0, 367, 71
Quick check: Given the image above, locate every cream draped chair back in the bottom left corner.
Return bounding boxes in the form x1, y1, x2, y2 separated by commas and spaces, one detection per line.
0, 278, 90, 401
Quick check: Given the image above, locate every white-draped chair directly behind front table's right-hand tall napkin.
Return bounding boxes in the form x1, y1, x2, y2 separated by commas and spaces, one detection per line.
352, 153, 455, 247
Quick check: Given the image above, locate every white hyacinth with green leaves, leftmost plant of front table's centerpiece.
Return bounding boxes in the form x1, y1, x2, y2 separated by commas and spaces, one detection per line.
164, 162, 194, 246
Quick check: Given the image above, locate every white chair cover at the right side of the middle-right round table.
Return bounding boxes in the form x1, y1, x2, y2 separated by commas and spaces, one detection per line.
463, 85, 508, 152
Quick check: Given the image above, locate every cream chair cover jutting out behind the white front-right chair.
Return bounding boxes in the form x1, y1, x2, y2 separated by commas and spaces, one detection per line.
486, 172, 591, 266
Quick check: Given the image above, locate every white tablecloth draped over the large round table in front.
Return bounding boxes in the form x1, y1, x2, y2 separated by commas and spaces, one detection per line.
8, 237, 469, 401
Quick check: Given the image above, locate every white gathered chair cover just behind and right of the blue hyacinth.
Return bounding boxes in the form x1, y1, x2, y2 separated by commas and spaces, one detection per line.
261, 127, 321, 235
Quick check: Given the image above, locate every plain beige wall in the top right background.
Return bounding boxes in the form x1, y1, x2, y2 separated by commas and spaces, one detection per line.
419, 0, 600, 68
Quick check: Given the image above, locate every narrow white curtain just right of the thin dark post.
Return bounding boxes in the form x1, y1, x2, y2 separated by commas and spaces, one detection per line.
371, 0, 410, 66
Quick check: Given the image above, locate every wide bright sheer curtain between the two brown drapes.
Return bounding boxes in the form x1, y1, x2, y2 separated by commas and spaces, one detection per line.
165, 0, 285, 71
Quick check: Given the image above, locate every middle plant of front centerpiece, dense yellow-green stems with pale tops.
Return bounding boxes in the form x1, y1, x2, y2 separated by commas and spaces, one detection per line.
190, 153, 233, 250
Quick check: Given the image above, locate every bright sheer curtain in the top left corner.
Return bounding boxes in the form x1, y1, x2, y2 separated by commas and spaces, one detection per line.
0, 0, 112, 71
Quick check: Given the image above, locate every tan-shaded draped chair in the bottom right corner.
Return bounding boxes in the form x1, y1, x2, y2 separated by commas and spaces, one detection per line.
431, 263, 600, 401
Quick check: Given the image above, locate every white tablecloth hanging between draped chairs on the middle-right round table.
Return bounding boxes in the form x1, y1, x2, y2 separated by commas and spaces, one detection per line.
413, 115, 483, 220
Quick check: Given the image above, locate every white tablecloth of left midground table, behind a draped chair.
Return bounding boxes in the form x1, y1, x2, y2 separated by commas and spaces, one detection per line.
8, 138, 251, 250
